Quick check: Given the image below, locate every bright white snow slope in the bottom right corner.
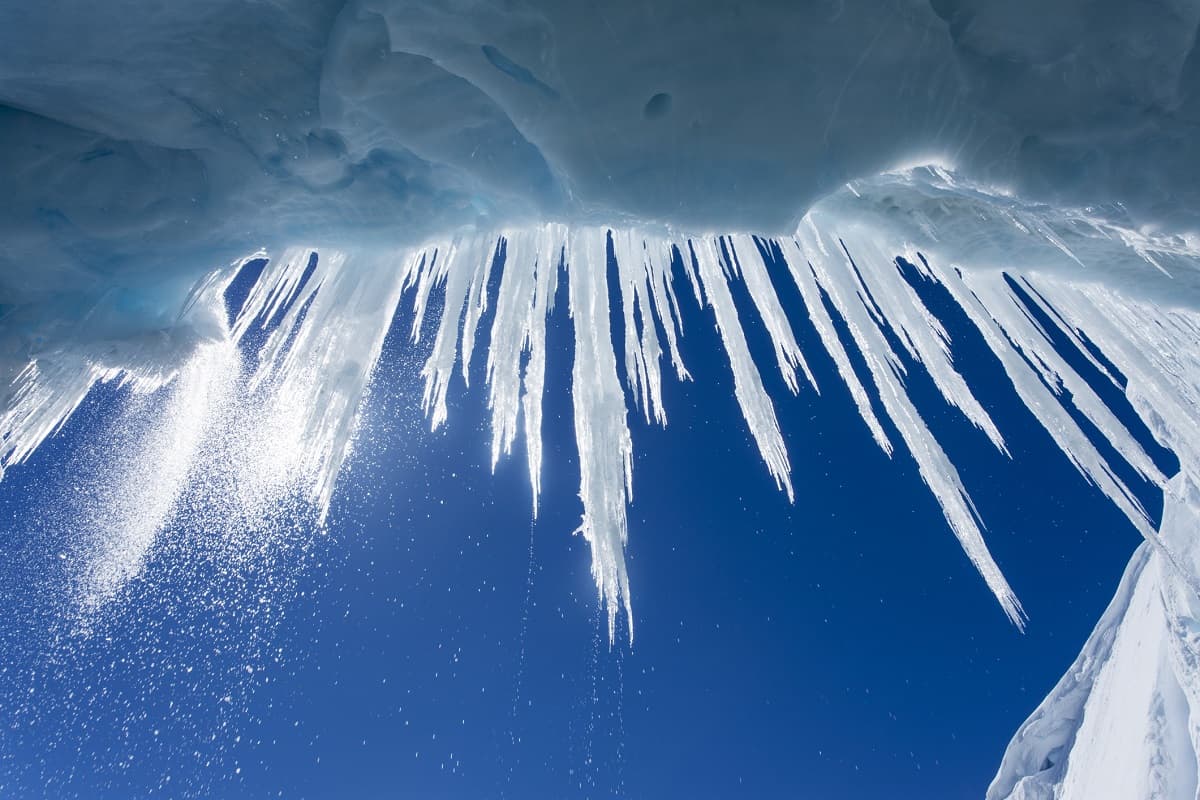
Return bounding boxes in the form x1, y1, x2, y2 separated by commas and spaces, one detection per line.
988, 475, 1200, 800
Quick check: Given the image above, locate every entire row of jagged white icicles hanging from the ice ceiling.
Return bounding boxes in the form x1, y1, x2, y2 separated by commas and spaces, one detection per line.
0, 181, 1200, 640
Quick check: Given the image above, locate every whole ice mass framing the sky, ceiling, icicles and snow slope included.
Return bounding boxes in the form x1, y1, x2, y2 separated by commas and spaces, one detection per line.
0, 0, 1200, 799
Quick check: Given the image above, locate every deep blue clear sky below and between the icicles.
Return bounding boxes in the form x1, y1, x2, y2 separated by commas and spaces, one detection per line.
0, 242, 1170, 800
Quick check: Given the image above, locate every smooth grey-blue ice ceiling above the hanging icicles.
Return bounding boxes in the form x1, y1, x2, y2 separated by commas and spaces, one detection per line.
7, 0, 1200, 291
